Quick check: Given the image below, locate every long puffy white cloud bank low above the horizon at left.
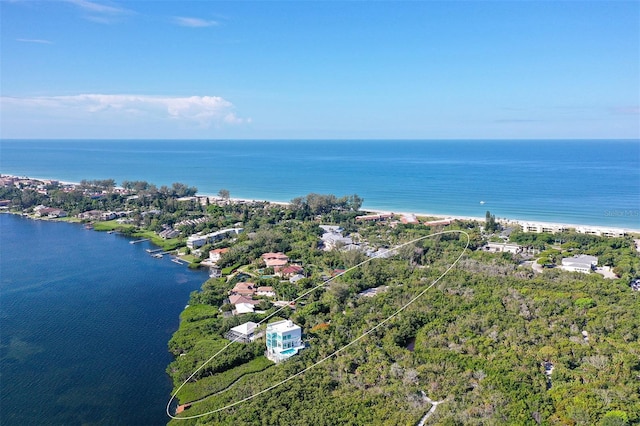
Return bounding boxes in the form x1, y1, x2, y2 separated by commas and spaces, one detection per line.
0, 94, 250, 127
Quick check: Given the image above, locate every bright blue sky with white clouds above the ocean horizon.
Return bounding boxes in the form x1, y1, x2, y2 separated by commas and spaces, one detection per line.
0, 0, 640, 139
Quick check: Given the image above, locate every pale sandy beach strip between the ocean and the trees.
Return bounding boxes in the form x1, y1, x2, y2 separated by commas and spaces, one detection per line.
1, 174, 640, 238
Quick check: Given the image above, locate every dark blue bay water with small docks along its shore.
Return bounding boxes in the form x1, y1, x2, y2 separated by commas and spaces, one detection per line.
0, 214, 207, 426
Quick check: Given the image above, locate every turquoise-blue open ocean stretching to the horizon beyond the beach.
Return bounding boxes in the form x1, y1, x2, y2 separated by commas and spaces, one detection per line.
0, 140, 640, 229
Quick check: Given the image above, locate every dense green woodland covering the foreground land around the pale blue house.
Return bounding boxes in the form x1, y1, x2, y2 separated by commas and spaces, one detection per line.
168, 202, 640, 425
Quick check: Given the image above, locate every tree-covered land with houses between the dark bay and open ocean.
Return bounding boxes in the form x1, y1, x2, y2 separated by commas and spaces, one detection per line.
0, 177, 640, 425
